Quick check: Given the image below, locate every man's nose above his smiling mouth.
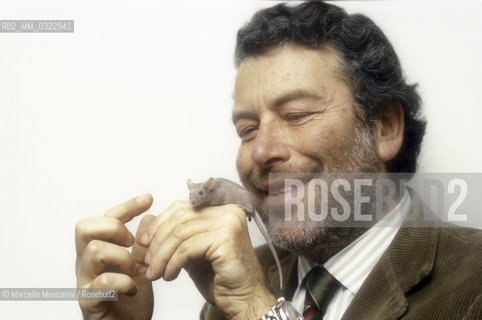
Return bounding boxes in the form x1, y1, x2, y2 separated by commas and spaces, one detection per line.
251, 127, 290, 168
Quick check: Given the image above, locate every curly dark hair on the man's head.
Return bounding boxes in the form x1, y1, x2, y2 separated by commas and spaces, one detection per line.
235, 1, 426, 172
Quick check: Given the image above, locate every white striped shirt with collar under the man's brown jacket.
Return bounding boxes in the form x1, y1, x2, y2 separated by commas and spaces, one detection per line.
292, 191, 412, 320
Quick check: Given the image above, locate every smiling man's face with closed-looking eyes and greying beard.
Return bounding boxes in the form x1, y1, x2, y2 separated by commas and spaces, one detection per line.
233, 45, 383, 260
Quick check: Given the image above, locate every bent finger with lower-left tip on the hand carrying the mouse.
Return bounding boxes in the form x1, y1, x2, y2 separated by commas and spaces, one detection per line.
144, 218, 223, 280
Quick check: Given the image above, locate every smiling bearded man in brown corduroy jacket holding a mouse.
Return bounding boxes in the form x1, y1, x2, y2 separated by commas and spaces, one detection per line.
76, 1, 482, 320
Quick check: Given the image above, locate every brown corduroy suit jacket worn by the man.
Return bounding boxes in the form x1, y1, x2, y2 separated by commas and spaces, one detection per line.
200, 192, 482, 320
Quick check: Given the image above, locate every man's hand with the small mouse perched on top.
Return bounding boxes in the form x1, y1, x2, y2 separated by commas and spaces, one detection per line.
141, 202, 276, 319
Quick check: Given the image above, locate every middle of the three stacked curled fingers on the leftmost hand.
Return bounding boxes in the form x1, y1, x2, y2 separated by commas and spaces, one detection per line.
78, 240, 137, 282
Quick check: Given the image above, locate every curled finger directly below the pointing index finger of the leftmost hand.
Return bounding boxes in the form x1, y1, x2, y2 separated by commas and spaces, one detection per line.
75, 217, 134, 256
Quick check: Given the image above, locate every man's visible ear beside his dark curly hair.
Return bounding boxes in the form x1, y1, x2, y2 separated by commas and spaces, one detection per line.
376, 101, 405, 162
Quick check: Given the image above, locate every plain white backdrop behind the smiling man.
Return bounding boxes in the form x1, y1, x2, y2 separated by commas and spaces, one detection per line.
0, 1, 482, 319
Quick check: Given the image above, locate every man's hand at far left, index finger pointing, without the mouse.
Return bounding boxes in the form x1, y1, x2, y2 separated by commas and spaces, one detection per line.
75, 194, 154, 320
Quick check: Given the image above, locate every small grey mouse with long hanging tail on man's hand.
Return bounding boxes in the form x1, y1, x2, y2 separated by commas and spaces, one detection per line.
186, 178, 283, 290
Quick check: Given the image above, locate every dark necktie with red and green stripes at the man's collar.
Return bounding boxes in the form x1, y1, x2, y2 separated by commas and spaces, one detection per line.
303, 267, 340, 320
